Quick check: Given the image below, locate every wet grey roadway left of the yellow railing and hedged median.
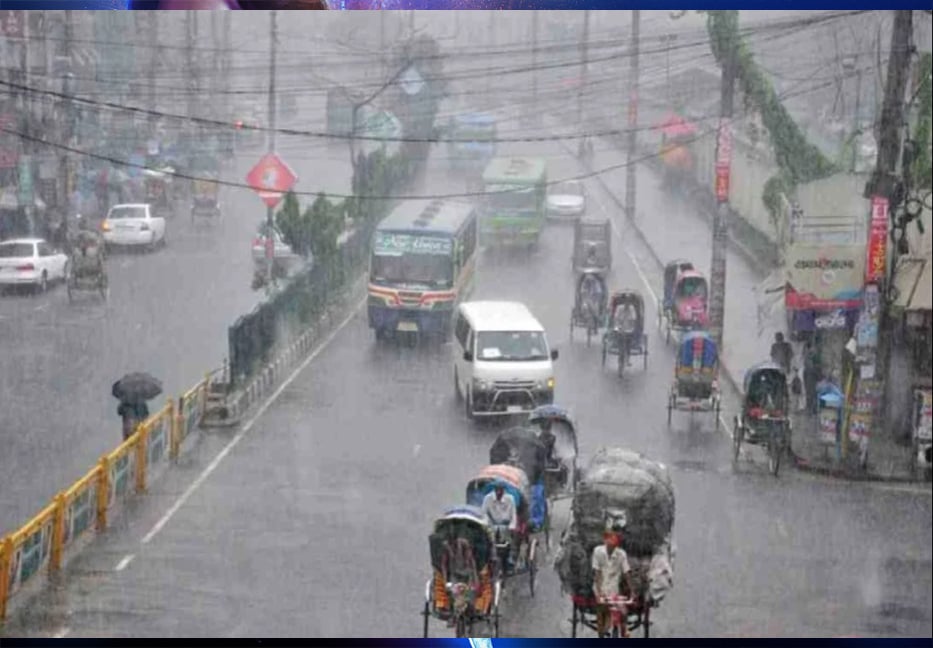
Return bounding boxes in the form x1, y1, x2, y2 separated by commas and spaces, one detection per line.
0, 116, 350, 535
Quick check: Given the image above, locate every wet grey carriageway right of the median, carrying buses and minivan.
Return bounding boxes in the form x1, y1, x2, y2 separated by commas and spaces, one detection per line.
8, 106, 933, 637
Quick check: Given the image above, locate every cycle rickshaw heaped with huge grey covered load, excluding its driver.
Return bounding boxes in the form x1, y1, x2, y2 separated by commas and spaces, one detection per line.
555, 448, 674, 638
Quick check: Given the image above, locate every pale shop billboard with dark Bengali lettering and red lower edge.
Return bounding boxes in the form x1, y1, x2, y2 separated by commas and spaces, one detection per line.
785, 243, 865, 310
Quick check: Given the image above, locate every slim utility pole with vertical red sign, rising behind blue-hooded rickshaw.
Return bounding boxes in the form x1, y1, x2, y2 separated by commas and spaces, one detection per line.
709, 12, 738, 350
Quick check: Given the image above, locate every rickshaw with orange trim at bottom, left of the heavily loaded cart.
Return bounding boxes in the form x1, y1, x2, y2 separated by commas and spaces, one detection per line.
422, 506, 502, 638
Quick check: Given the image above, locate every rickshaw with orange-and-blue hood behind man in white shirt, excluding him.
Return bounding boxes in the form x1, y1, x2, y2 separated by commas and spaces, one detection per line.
466, 464, 548, 596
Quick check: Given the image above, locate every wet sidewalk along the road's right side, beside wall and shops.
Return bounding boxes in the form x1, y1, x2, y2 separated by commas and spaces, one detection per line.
572, 116, 916, 481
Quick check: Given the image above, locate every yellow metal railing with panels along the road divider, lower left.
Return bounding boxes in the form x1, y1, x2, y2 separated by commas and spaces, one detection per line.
0, 375, 210, 623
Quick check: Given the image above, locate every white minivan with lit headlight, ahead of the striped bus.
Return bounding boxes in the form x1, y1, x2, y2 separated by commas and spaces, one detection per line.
453, 301, 557, 418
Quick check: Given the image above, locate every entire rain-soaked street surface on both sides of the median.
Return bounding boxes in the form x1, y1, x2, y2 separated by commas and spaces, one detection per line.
0, 12, 933, 638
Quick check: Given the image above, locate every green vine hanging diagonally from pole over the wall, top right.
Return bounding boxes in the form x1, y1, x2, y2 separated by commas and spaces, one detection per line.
707, 11, 837, 218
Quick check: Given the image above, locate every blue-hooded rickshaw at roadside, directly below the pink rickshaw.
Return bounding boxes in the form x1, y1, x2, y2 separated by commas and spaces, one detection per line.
667, 331, 722, 429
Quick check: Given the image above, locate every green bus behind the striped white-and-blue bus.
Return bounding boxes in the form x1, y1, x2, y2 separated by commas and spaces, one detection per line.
480, 157, 547, 246
